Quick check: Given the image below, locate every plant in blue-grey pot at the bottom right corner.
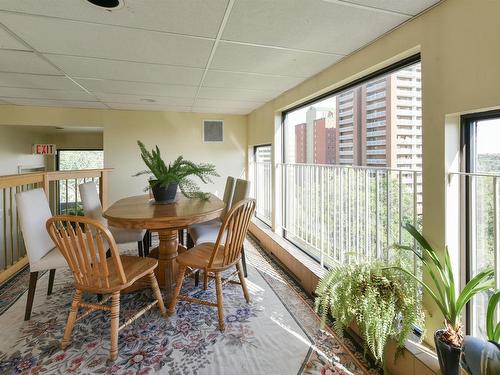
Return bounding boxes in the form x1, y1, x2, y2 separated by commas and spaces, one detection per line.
460, 290, 500, 375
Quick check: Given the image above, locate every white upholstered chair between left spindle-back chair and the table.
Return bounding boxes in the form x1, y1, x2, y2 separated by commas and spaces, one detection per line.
78, 182, 148, 256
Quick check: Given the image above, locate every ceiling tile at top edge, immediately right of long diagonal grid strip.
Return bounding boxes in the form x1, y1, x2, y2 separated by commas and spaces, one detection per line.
222, 0, 410, 54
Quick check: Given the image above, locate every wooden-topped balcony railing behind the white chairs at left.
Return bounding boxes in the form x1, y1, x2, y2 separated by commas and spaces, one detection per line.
0, 169, 110, 282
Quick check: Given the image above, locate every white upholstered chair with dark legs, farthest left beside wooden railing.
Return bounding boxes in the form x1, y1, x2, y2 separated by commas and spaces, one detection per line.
16, 189, 68, 320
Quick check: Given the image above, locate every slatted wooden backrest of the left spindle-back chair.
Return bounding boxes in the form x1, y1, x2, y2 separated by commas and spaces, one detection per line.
47, 216, 127, 289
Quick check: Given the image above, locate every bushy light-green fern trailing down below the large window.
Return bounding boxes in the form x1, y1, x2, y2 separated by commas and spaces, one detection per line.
315, 262, 423, 367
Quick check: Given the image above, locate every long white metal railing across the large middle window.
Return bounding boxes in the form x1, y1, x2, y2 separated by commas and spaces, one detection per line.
277, 164, 421, 268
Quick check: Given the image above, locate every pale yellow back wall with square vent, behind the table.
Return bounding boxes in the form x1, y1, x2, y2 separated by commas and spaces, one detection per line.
0, 105, 247, 202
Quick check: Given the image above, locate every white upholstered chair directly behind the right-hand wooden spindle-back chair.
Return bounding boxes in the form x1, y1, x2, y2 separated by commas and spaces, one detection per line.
189, 177, 250, 279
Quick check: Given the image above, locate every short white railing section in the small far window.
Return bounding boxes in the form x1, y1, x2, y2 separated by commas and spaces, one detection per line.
253, 162, 273, 225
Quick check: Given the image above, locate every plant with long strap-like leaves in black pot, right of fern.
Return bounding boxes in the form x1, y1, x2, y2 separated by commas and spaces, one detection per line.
390, 224, 494, 375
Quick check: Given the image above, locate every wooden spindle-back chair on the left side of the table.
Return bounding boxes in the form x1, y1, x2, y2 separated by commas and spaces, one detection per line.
47, 216, 166, 360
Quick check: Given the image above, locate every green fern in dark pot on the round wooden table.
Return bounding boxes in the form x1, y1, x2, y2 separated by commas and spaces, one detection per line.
134, 141, 219, 203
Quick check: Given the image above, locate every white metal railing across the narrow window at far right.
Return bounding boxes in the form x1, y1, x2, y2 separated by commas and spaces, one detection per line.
448, 172, 500, 336
